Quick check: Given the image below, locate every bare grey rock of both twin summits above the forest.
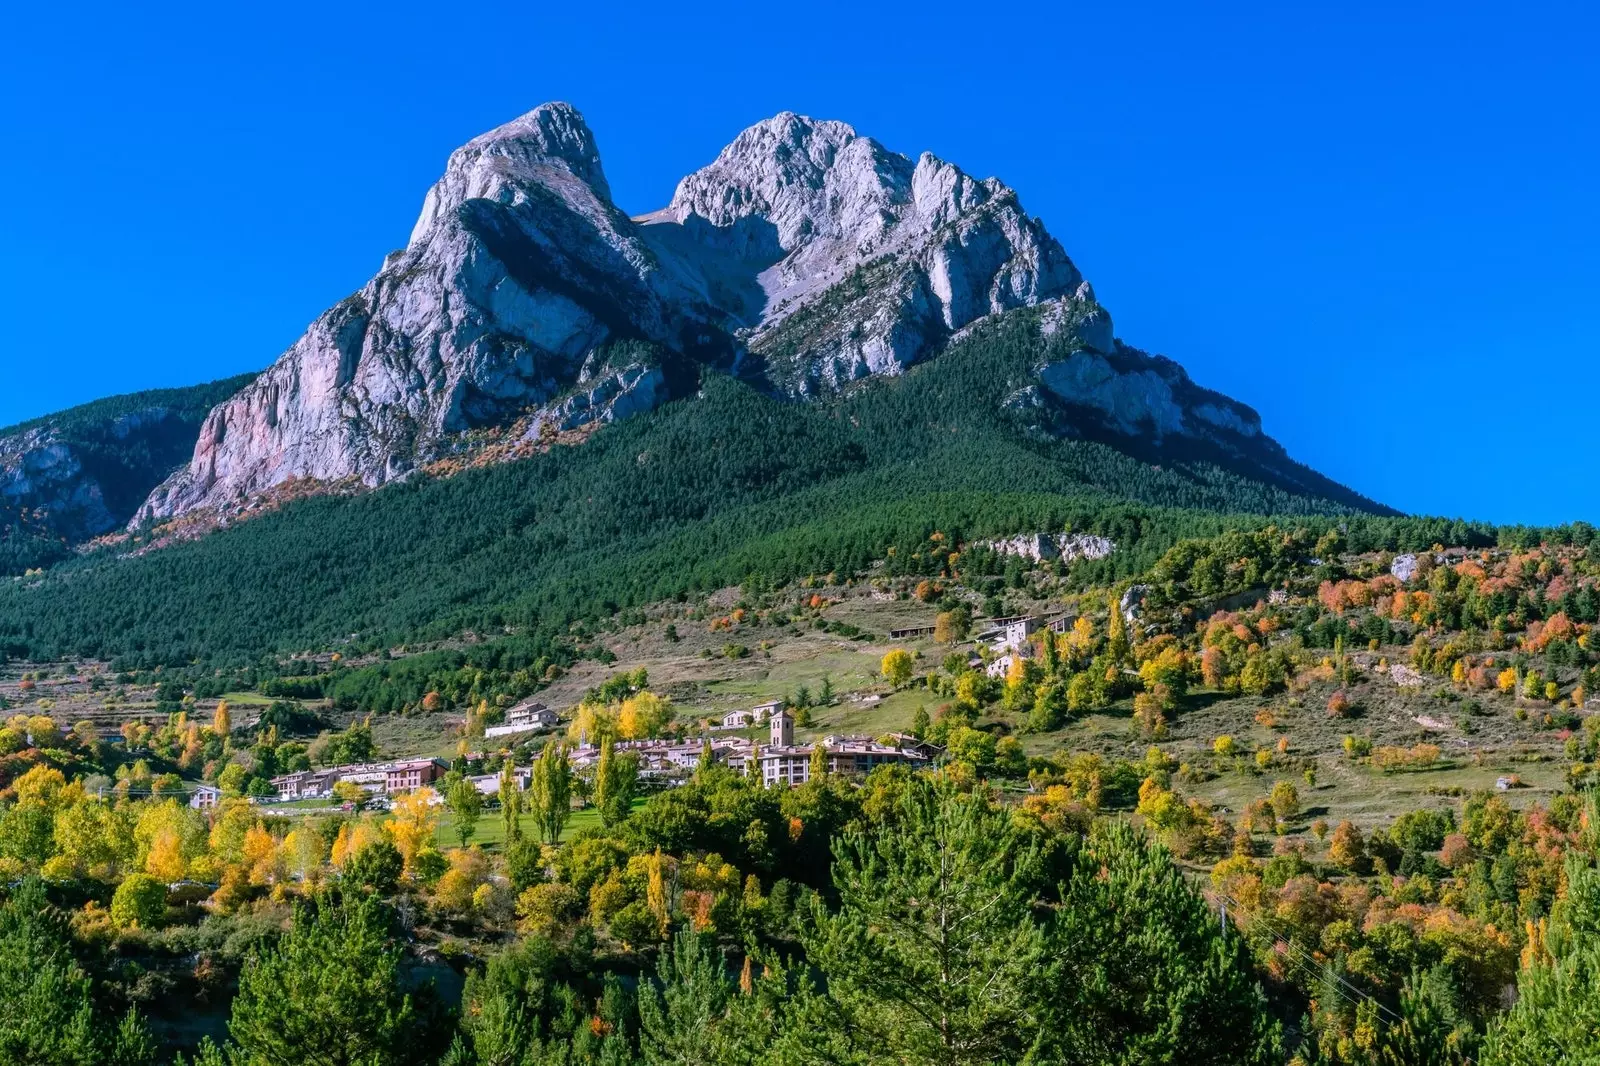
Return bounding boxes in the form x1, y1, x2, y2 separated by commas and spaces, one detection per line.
136, 104, 1291, 520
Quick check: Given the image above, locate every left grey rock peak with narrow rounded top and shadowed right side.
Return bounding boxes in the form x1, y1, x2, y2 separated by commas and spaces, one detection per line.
139, 104, 725, 519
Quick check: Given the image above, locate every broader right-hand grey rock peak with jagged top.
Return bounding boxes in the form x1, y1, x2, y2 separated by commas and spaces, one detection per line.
642, 112, 1086, 394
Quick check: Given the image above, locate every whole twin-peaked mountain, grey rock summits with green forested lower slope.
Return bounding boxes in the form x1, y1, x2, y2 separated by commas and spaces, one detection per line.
0, 104, 1401, 666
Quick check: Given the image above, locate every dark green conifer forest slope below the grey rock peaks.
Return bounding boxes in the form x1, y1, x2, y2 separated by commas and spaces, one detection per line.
0, 322, 1523, 663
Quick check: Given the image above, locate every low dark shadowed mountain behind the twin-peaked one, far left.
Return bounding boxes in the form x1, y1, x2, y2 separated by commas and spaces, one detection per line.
0, 375, 254, 575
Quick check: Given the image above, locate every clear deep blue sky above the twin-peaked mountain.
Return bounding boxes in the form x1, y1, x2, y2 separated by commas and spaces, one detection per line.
0, 0, 1600, 522
